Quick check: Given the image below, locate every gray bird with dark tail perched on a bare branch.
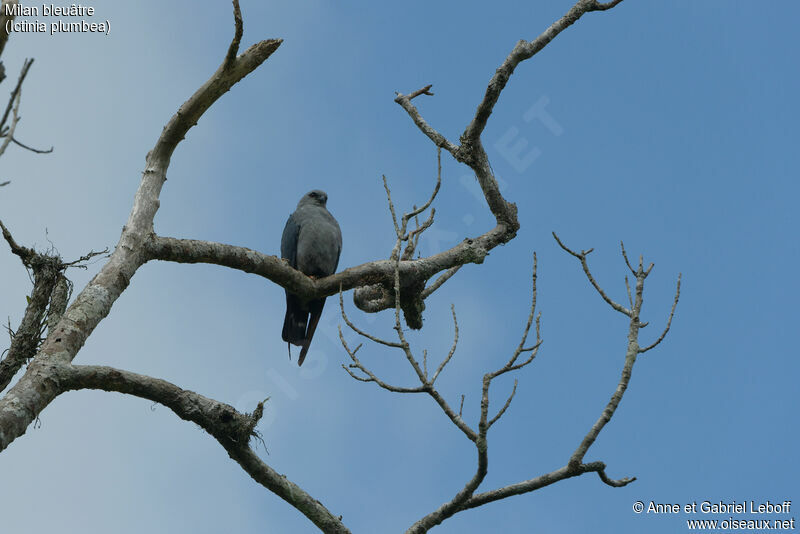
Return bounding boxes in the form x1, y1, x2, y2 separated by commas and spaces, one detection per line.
281, 189, 342, 365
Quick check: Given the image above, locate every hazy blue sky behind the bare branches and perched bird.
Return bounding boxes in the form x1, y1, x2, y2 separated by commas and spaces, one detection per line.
0, 0, 800, 533
